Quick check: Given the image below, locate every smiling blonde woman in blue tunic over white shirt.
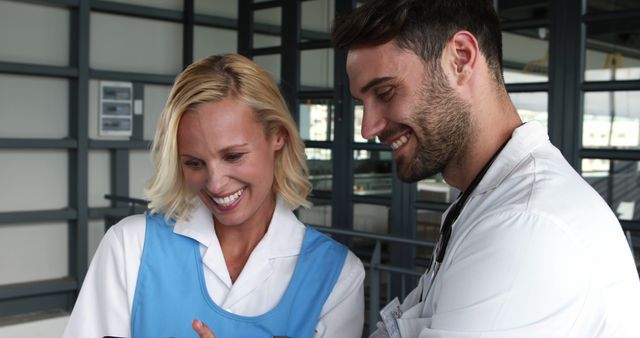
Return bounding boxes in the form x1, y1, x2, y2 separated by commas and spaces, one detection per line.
64, 54, 364, 338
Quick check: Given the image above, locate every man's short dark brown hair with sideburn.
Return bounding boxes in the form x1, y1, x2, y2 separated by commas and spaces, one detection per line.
331, 0, 504, 83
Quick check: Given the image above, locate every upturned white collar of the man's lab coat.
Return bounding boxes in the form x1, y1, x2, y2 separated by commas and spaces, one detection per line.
472, 121, 549, 196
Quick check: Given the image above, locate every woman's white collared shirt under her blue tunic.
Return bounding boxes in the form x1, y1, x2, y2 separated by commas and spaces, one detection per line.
64, 198, 364, 338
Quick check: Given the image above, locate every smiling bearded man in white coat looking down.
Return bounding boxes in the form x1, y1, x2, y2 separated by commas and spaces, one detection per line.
332, 0, 640, 338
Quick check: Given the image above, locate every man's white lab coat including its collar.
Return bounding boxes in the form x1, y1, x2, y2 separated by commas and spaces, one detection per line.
380, 122, 640, 338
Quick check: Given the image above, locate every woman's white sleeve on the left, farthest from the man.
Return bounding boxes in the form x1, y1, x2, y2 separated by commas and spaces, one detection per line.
63, 216, 144, 338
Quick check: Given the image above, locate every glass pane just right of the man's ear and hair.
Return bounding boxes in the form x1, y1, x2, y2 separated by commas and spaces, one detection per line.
502, 27, 549, 83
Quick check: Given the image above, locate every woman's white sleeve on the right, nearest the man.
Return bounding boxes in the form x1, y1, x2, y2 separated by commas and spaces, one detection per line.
314, 251, 364, 338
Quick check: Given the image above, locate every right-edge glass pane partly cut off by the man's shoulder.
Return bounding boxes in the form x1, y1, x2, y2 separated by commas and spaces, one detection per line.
582, 159, 640, 220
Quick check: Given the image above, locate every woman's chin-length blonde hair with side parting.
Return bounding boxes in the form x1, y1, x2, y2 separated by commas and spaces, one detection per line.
145, 54, 311, 220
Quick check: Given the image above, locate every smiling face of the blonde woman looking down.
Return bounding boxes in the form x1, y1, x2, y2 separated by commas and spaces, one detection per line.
178, 96, 284, 227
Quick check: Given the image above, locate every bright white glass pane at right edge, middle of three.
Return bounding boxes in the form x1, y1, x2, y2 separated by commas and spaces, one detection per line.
582, 91, 640, 149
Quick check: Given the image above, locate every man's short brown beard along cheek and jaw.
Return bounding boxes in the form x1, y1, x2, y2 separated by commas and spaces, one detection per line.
397, 66, 472, 182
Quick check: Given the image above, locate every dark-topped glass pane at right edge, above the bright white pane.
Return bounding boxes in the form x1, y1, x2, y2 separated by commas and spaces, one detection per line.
584, 20, 640, 81
